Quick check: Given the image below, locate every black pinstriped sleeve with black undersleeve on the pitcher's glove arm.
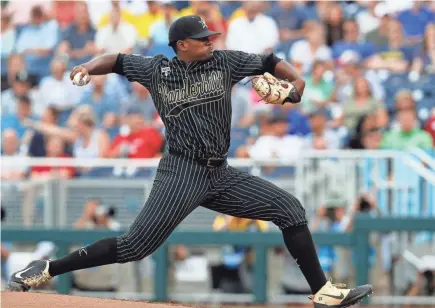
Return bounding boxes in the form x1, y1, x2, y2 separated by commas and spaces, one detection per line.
225, 50, 281, 83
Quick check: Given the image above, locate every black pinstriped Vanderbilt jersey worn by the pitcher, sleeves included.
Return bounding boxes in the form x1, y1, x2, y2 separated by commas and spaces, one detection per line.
118, 50, 265, 157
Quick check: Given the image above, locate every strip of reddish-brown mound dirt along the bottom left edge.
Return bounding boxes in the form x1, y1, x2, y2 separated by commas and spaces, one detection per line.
1, 292, 199, 308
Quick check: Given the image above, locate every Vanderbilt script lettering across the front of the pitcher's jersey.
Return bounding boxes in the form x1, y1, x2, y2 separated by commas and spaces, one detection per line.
159, 71, 224, 117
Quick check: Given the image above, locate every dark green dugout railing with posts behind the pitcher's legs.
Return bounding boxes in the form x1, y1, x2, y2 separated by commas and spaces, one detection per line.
1, 215, 435, 303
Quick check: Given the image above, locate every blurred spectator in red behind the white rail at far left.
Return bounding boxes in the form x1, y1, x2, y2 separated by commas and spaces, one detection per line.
30, 136, 75, 179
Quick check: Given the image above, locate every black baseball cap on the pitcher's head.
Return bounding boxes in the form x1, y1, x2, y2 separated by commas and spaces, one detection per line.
168, 15, 220, 46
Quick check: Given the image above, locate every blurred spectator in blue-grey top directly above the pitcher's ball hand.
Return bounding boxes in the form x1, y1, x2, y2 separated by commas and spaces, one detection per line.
57, 2, 97, 69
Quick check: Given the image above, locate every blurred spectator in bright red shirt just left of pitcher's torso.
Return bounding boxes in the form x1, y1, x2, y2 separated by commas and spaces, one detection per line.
109, 106, 163, 158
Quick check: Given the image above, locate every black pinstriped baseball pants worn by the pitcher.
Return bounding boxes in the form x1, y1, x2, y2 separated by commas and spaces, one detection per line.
117, 154, 307, 263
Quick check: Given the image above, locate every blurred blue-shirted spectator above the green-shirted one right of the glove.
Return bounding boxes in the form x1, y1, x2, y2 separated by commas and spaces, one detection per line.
332, 20, 373, 59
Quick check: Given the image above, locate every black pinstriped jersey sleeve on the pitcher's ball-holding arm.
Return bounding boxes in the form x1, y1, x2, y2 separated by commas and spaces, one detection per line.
113, 54, 160, 88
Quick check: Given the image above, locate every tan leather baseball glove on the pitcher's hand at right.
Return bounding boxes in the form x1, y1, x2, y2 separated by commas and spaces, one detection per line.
252, 73, 301, 105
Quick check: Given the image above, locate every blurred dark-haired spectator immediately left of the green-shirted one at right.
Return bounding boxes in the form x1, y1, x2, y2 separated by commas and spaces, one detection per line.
347, 114, 382, 150
